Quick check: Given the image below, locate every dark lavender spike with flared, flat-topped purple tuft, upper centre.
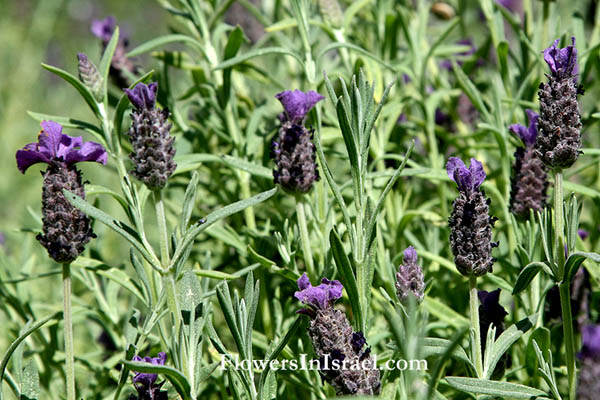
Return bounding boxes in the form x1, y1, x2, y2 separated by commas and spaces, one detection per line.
271, 90, 324, 193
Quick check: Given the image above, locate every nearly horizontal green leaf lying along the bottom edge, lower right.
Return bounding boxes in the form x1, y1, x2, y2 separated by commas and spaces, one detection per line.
446, 376, 548, 400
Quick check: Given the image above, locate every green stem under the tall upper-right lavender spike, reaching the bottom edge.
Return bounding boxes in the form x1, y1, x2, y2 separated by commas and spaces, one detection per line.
554, 170, 576, 400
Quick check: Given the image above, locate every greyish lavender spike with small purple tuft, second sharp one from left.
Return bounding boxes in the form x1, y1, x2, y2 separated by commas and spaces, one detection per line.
125, 82, 177, 190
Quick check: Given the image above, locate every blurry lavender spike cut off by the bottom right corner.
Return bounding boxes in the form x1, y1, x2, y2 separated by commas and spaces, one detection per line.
577, 325, 600, 400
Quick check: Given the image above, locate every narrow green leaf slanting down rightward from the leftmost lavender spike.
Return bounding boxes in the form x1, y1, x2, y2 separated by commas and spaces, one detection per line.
63, 189, 160, 267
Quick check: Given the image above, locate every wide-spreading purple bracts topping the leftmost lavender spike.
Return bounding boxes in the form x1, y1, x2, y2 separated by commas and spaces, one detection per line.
17, 121, 107, 173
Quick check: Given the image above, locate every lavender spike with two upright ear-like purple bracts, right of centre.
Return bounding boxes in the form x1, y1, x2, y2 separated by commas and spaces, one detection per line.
446, 157, 498, 276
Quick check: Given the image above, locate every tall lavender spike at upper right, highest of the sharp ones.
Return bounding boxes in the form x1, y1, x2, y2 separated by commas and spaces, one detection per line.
535, 38, 583, 171
